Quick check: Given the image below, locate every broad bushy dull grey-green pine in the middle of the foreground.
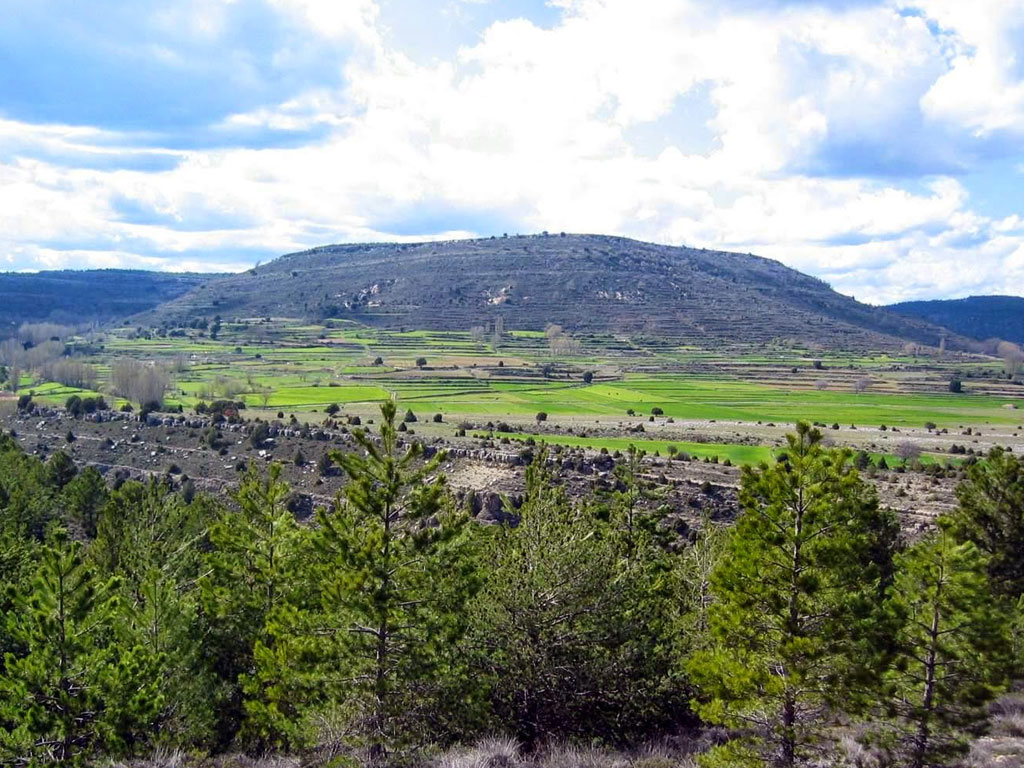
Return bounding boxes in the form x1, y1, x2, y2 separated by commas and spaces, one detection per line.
473, 450, 678, 746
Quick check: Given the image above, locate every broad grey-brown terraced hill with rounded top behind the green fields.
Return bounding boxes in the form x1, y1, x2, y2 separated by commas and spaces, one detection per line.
139, 234, 966, 348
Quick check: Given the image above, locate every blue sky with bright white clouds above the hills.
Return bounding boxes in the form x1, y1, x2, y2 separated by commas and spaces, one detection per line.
0, 0, 1024, 303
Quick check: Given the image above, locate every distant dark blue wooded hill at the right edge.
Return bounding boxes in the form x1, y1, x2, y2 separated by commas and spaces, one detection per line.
887, 296, 1024, 344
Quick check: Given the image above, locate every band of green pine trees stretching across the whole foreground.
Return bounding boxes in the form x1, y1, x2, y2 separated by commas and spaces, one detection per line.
0, 402, 1024, 768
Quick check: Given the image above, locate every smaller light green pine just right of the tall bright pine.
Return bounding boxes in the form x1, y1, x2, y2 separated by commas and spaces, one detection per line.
886, 530, 1009, 768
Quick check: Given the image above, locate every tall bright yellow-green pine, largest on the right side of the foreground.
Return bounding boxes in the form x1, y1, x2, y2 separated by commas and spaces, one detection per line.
687, 423, 897, 768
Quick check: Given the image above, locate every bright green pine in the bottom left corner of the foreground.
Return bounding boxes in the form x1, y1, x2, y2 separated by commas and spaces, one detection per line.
0, 532, 161, 764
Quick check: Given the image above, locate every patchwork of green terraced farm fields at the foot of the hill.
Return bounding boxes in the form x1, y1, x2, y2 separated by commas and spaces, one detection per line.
9, 318, 1024, 473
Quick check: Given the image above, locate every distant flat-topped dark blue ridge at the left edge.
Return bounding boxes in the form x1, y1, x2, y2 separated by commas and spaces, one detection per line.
0, 269, 220, 335
